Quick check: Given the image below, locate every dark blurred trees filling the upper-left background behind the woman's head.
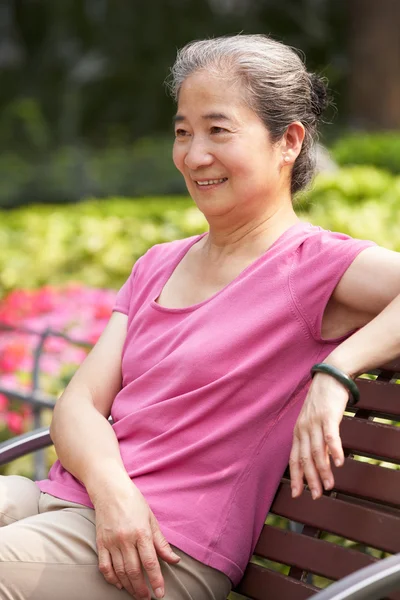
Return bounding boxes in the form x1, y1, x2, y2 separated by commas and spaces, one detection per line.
0, 0, 346, 155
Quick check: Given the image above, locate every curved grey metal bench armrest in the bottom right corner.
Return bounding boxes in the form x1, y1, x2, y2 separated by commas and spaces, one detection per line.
312, 554, 400, 600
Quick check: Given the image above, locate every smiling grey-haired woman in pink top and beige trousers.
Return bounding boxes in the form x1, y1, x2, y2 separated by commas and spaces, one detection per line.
0, 35, 400, 600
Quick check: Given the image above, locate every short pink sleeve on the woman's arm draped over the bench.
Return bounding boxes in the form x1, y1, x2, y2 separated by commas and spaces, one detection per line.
289, 227, 376, 341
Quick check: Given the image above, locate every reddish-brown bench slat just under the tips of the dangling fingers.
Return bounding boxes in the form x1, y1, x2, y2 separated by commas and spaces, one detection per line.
271, 483, 400, 554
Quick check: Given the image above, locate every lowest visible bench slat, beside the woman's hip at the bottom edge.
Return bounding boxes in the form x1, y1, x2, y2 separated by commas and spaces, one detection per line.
235, 563, 318, 600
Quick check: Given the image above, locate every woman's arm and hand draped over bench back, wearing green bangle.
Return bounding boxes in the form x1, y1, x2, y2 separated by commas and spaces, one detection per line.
289, 247, 400, 498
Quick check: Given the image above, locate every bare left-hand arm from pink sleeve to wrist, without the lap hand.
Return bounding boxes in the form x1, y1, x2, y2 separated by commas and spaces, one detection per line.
50, 313, 130, 503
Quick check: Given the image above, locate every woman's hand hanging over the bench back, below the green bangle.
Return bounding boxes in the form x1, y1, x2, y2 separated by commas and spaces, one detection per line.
289, 373, 349, 500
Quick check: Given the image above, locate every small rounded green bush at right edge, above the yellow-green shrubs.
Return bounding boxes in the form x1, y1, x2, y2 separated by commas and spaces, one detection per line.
331, 132, 400, 174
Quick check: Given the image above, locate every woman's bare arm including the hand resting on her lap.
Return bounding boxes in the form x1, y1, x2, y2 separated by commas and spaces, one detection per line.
50, 312, 180, 598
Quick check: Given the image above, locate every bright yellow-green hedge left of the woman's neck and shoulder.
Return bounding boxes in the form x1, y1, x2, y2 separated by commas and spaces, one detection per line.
0, 197, 205, 297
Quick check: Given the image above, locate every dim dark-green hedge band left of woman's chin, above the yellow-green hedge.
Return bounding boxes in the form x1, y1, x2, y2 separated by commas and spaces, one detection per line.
0, 135, 185, 208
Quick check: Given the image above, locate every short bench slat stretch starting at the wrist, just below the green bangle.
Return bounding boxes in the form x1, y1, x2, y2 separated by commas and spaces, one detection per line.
356, 379, 400, 420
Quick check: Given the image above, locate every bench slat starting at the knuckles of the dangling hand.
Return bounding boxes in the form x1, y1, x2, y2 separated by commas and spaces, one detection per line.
340, 417, 400, 463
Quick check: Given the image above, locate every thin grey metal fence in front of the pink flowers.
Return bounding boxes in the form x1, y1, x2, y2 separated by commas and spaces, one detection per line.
0, 321, 92, 479
